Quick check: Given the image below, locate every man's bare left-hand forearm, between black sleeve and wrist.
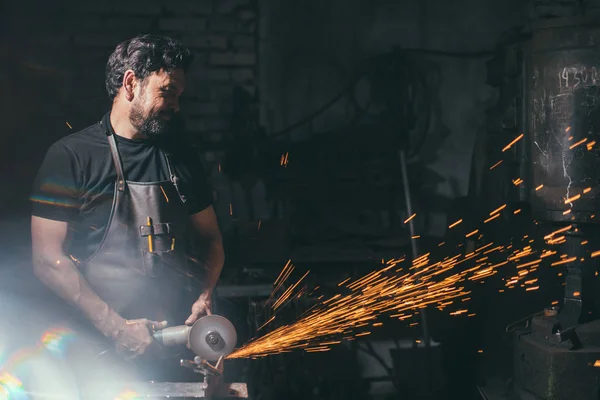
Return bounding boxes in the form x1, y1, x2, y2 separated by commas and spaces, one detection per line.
33, 255, 125, 337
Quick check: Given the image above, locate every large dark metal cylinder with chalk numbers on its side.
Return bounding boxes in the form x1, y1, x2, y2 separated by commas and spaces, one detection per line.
525, 18, 600, 222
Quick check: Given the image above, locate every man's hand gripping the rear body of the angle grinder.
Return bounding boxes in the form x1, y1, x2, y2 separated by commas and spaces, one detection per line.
115, 318, 167, 357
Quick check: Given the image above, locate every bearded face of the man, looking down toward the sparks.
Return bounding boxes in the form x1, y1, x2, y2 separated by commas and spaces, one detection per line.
129, 69, 185, 138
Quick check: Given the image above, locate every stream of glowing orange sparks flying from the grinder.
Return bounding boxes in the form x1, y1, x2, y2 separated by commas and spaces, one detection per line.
228, 134, 600, 358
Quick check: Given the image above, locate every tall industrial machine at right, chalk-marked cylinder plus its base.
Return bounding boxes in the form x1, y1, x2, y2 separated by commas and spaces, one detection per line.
480, 17, 600, 400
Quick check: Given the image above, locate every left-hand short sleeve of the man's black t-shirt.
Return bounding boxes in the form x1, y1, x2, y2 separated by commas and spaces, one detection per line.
30, 143, 80, 222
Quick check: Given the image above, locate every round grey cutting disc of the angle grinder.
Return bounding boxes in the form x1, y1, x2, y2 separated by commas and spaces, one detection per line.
189, 315, 237, 361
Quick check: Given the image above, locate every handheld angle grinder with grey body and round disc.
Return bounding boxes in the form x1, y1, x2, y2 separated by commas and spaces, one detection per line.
153, 315, 237, 361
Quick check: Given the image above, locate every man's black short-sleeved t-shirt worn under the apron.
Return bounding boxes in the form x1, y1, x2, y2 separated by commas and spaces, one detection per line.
31, 114, 212, 260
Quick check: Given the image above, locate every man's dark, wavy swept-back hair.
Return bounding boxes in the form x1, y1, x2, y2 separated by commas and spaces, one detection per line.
105, 35, 193, 100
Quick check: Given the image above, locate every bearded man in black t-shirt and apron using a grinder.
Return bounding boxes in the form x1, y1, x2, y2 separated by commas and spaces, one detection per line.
31, 35, 224, 368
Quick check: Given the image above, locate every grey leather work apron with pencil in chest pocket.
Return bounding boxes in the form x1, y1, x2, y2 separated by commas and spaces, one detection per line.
80, 120, 190, 325
